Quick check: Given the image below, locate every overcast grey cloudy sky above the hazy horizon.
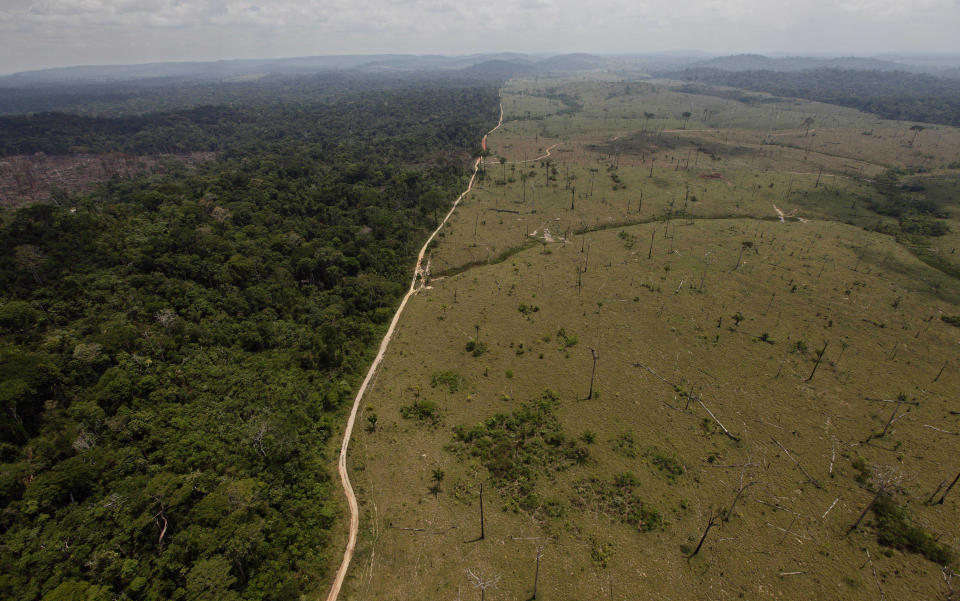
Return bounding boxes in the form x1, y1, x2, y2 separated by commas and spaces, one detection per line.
0, 0, 960, 73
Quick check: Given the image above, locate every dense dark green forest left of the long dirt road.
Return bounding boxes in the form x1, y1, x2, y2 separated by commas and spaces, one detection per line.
0, 80, 498, 601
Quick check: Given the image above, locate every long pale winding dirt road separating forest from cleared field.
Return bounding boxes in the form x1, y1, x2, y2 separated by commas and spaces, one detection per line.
327, 103, 503, 601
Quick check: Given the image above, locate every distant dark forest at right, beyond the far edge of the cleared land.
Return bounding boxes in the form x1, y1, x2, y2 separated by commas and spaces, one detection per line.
669, 69, 960, 125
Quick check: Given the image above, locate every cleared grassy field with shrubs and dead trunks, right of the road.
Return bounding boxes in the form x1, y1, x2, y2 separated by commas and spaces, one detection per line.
332, 75, 960, 601
